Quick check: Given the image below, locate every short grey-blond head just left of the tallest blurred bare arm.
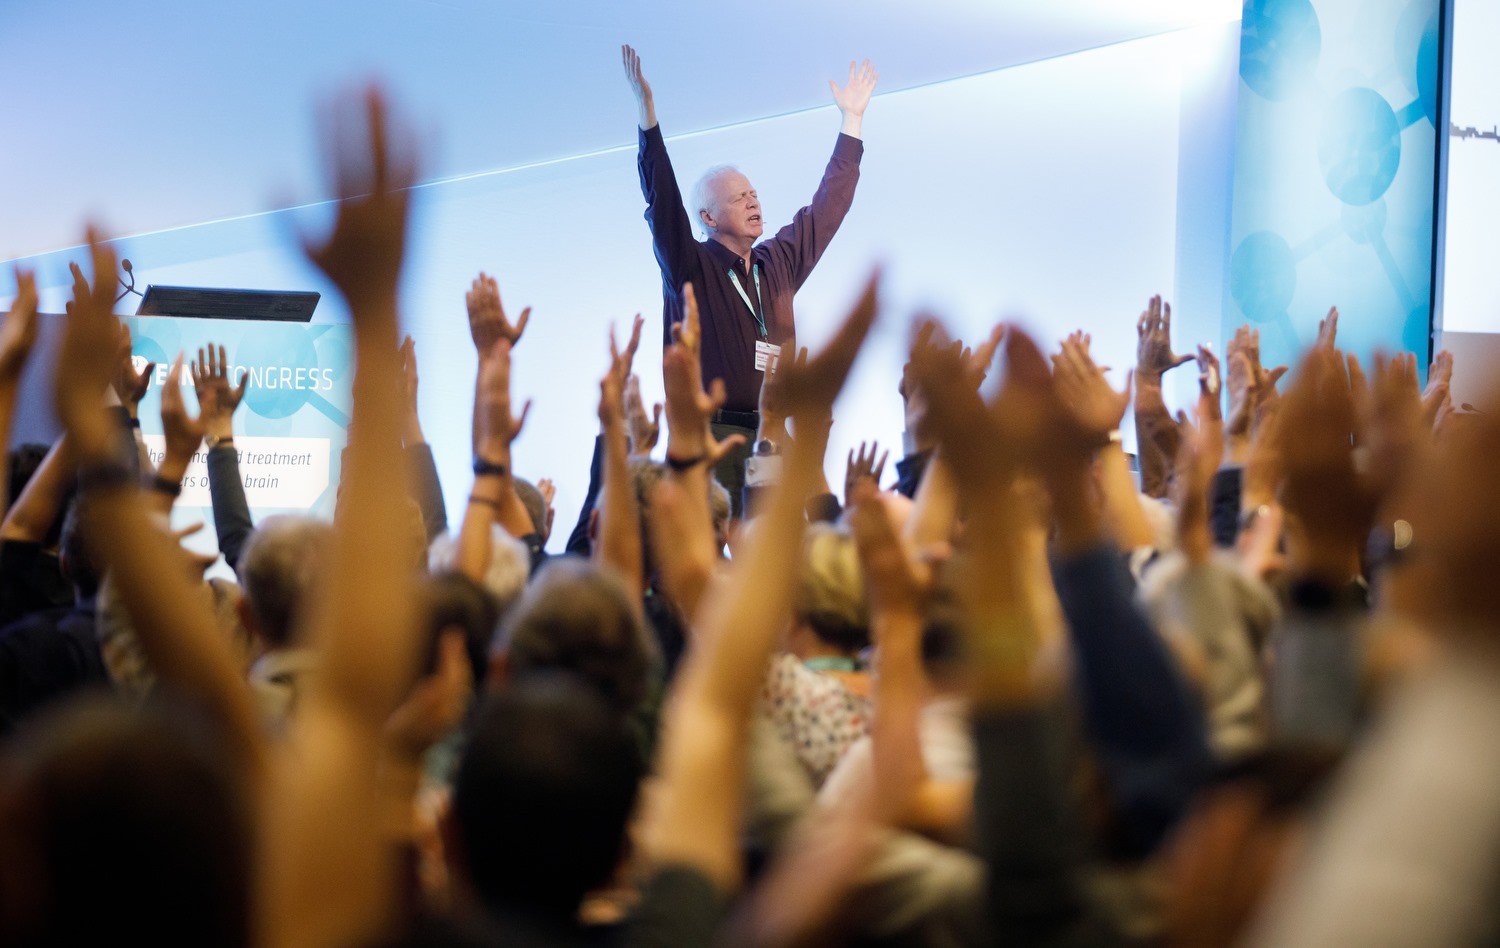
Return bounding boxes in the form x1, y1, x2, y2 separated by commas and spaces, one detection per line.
239, 515, 333, 651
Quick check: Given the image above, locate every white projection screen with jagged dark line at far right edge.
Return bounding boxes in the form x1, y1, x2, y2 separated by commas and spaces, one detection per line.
1439, 0, 1500, 333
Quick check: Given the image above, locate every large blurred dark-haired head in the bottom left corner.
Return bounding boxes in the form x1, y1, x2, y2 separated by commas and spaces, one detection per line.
0, 699, 255, 945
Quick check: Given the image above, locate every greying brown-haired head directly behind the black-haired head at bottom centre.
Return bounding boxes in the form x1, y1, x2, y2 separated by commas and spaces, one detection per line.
492, 560, 657, 717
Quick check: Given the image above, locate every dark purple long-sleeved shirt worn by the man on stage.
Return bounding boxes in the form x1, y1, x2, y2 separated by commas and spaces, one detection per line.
638, 125, 864, 411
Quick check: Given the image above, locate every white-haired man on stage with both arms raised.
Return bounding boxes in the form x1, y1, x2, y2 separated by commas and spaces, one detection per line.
621, 47, 876, 515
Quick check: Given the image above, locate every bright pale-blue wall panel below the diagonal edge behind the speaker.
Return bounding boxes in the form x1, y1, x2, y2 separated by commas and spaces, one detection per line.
0, 18, 1239, 548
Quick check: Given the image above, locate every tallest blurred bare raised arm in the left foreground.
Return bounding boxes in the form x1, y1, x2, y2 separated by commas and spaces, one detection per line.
266, 89, 420, 945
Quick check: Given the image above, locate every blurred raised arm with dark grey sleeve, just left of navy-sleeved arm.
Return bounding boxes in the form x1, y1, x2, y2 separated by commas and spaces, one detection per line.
912, 322, 1098, 945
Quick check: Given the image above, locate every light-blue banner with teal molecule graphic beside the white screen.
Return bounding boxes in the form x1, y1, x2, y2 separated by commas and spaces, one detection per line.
1229, 0, 1439, 360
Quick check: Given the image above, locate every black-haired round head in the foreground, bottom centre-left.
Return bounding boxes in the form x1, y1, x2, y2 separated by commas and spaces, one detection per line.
446, 675, 644, 924
